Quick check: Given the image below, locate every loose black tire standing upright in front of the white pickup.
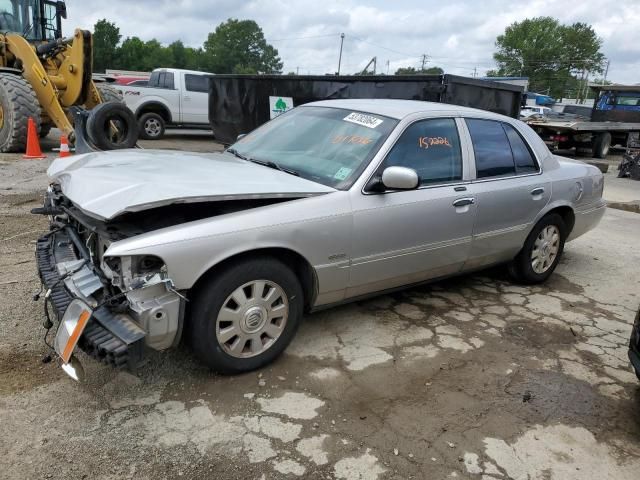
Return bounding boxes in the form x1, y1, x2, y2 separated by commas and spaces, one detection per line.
87, 102, 138, 150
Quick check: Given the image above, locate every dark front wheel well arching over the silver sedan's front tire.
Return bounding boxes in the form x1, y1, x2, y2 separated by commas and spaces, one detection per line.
191, 248, 317, 311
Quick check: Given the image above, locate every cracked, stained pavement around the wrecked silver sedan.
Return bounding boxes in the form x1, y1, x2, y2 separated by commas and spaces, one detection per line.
0, 134, 640, 480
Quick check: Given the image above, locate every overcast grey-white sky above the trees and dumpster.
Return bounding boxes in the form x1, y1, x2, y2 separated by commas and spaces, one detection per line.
65, 0, 640, 83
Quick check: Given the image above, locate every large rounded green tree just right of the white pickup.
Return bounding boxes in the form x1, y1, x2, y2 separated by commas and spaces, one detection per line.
204, 18, 282, 73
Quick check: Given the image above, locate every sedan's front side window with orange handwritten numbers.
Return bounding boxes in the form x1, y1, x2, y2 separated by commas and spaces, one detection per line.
383, 118, 462, 185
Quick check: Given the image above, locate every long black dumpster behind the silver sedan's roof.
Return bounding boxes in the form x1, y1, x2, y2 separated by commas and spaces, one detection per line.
209, 75, 523, 143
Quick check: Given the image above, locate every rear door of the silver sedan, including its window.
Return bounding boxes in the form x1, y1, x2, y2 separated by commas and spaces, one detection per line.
465, 118, 551, 269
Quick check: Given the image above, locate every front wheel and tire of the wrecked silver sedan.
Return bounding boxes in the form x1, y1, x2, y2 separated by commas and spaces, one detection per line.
190, 257, 304, 375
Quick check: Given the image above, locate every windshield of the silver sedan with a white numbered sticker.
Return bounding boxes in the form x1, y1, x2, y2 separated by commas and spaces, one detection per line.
229, 107, 398, 190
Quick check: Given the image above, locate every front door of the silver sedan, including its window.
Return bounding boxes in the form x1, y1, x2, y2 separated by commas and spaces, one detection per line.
347, 118, 476, 297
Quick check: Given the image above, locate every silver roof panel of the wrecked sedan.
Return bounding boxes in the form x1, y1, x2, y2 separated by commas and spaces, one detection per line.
301, 98, 509, 120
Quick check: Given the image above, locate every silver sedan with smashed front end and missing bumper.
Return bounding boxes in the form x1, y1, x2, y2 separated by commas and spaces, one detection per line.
36, 100, 605, 373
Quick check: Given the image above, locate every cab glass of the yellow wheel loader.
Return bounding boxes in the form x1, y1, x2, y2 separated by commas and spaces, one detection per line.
0, 0, 58, 40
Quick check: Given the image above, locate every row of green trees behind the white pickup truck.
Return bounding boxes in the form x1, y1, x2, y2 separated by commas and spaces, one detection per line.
93, 18, 282, 74
